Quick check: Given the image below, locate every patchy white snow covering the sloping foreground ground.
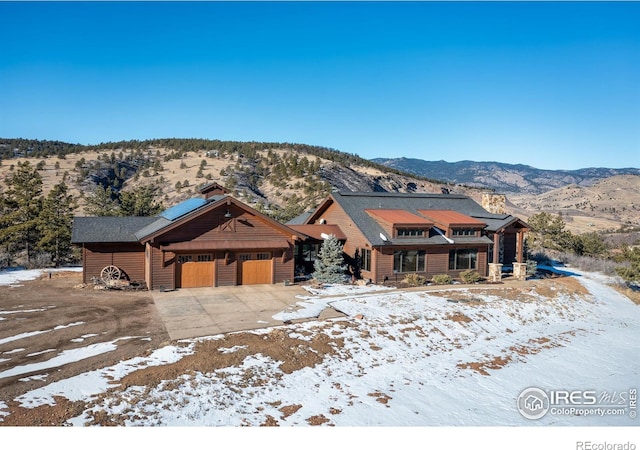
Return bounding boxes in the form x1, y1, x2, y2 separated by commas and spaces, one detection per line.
0, 270, 640, 448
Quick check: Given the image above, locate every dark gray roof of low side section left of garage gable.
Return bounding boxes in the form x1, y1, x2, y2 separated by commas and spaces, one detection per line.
71, 217, 158, 244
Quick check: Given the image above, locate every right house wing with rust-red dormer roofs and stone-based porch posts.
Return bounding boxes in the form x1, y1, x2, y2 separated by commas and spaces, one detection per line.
293, 192, 528, 283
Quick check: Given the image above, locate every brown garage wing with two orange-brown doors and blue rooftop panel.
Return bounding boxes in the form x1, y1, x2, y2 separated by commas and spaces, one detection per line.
72, 195, 307, 289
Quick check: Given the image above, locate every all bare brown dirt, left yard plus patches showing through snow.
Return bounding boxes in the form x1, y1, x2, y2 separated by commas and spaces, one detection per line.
0, 272, 632, 426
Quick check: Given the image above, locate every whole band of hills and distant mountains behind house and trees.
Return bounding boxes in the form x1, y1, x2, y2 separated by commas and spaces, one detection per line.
0, 138, 640, 232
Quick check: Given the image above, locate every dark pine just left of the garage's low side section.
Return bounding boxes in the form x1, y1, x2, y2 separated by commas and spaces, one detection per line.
38, 181, 77, 266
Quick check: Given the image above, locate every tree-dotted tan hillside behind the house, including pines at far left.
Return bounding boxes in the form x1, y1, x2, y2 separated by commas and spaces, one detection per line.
0, 139, 464, 265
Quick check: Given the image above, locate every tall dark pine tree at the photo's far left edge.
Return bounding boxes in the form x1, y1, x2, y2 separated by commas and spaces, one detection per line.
0, 161, 42, 263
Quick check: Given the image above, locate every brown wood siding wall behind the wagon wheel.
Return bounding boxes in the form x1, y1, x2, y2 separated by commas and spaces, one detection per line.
82, 243, 145, 283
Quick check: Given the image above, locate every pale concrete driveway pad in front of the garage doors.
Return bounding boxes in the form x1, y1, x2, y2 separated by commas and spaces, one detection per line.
151, 284, 340, 339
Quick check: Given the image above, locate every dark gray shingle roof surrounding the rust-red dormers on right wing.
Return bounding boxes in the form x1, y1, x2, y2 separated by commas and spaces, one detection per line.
332, 191, 516, 245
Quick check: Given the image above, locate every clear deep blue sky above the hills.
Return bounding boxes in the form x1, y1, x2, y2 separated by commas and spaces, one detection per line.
0, 2, 640, 169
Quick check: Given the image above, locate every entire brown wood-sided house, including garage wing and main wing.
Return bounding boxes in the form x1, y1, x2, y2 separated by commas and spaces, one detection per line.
72, 183, 528, 290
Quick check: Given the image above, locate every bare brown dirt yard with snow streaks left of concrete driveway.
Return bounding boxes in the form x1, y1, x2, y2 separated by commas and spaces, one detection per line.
0, 272, 169, 426
